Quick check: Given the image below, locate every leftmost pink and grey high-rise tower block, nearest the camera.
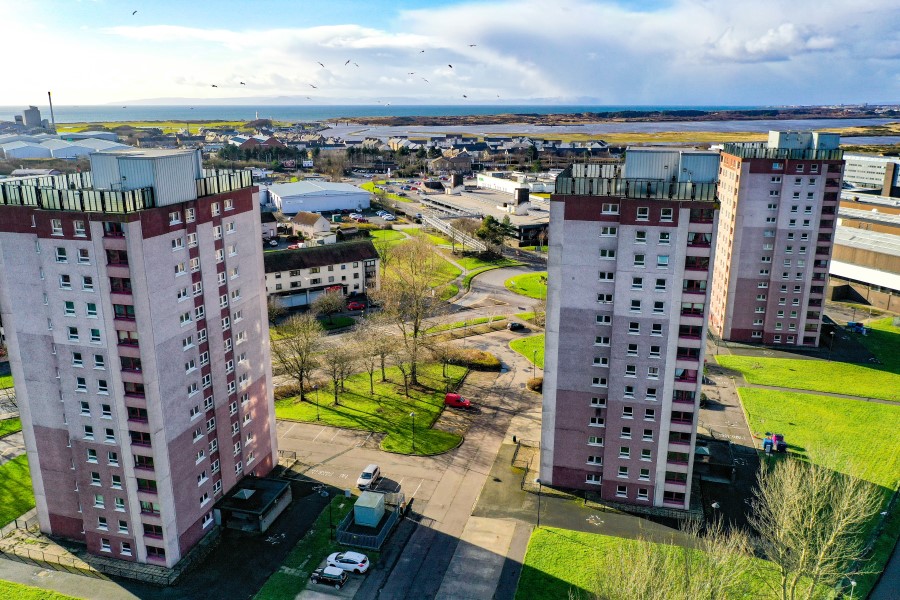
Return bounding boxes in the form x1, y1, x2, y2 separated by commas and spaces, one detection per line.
0, 149, 276, 567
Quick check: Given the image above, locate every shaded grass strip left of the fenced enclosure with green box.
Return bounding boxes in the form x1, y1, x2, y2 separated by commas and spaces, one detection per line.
254, 496, 362, 600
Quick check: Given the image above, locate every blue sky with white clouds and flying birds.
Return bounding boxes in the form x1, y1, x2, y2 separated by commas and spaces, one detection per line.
0, 0, 900, 106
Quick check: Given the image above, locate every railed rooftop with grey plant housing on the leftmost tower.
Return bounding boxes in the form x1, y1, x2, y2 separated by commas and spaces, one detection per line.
0, 149, 253, 213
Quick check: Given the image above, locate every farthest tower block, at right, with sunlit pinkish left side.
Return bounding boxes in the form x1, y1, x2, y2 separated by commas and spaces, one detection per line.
710, 131, 844, 347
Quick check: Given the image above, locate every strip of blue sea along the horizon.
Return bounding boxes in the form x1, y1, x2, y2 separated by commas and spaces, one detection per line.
0, 103, 765, 123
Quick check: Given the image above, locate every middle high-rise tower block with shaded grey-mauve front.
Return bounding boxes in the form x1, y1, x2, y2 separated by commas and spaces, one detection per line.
540, 148, 718, 509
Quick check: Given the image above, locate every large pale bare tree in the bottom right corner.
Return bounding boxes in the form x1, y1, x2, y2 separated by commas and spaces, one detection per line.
750, 458, 883, 600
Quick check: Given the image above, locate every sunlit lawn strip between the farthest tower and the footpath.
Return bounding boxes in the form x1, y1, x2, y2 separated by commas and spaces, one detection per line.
716, 355, 900, 402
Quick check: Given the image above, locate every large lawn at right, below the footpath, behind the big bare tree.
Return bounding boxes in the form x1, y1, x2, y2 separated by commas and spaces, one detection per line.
738, 387, 900, 598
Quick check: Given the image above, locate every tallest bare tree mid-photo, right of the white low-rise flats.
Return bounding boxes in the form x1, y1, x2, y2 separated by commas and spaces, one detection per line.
372, 237, 445, 385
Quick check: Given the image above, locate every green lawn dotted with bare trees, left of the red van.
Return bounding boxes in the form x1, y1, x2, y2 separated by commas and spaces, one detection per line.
275, 364, 466, 455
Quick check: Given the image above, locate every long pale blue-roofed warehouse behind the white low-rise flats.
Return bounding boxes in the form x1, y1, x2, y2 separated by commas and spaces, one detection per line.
269, 179, 370, 215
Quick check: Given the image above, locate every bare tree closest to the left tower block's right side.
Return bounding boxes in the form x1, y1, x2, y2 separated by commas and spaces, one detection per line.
272, 313, 325, 402
